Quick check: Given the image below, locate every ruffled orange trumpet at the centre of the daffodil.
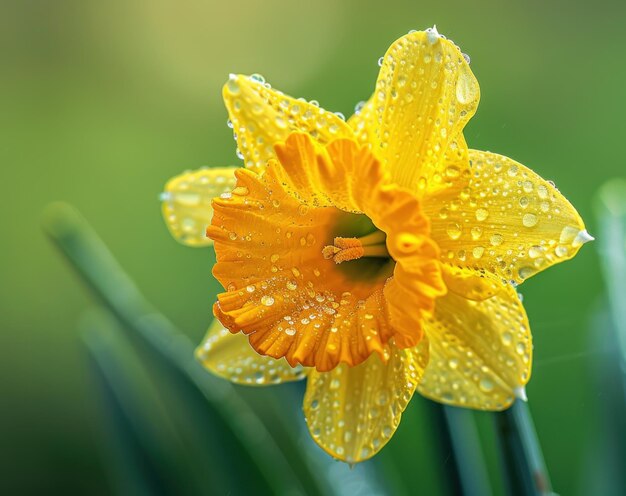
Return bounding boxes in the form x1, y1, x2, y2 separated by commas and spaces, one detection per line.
207, 133, 445, 371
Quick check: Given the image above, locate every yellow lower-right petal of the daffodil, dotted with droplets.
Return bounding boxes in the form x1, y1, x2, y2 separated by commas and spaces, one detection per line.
418, 285, 532, 410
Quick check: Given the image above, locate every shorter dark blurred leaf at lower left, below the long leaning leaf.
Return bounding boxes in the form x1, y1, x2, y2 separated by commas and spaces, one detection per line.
81, 310, 207, 494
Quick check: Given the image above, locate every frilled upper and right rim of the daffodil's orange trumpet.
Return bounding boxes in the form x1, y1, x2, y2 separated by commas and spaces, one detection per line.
276, 135, 446, 348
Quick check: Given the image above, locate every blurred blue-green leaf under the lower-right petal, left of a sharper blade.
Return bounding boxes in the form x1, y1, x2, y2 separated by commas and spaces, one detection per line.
429, 402, 493, 496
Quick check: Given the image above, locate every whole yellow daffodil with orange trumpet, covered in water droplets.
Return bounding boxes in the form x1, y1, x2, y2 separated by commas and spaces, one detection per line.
163, 29, 591, 462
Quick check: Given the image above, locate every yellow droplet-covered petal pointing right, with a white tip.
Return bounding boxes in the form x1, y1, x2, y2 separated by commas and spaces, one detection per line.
423, 150, 592, 283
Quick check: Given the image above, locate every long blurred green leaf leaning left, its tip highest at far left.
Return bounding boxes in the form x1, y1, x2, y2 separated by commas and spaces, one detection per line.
43, 203, 324, 494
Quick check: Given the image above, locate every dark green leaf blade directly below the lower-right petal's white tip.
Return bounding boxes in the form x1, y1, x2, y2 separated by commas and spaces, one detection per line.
496, 400, 554, 496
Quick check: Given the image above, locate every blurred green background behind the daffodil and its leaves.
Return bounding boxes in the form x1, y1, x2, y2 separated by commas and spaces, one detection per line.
0, 0, 626, 494
